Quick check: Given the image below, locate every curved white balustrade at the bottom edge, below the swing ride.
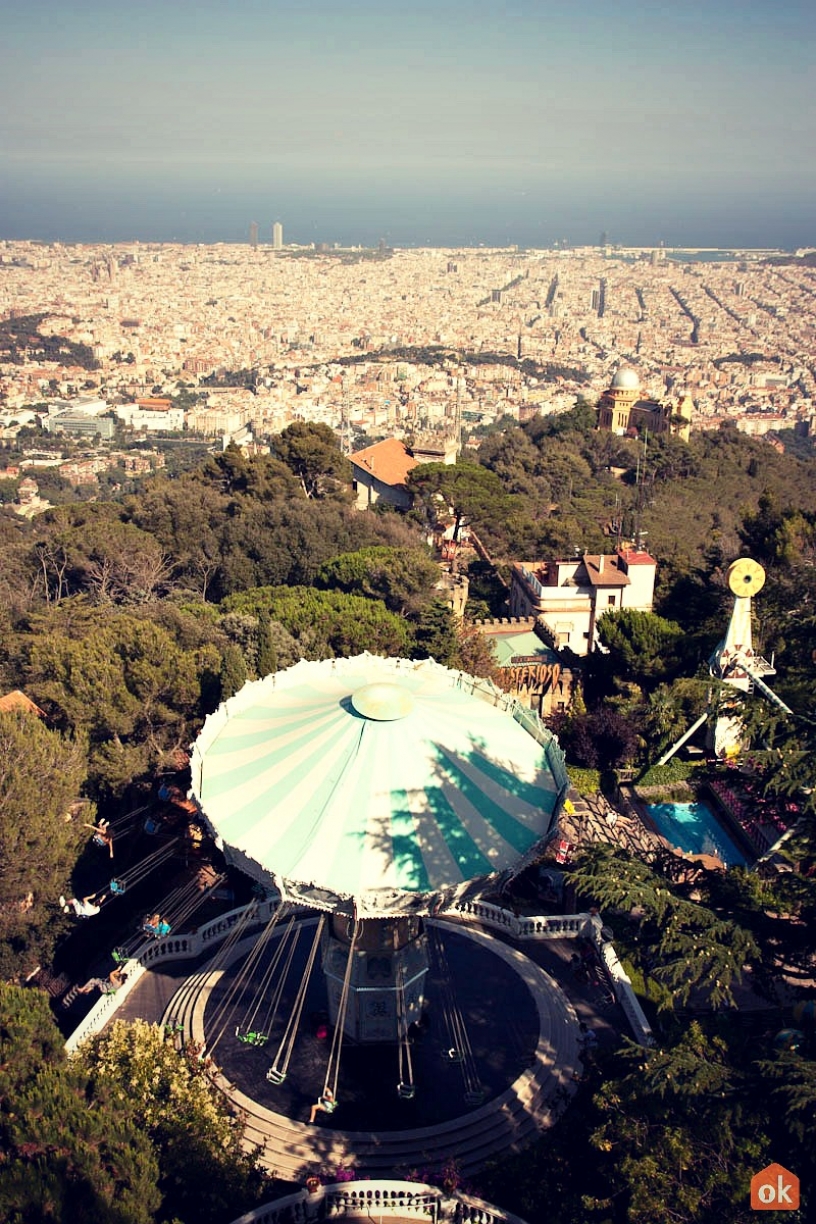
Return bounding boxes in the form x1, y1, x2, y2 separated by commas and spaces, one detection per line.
225, 1181, 524, 1224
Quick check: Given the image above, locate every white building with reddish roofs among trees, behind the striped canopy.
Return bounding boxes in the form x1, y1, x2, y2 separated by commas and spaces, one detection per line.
510, 547, 657, 655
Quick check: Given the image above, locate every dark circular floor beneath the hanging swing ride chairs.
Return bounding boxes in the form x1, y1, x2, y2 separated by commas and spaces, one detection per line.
184, 919, 576, 1132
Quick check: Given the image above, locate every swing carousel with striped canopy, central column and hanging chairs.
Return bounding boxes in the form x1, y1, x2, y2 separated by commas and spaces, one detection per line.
191, 655, 565, 1114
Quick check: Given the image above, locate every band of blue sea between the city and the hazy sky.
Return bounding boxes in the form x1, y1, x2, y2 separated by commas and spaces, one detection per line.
0, 170, 814, 250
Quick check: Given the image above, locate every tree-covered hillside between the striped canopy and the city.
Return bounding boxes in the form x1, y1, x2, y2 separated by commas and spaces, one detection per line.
0, 416, 816, 969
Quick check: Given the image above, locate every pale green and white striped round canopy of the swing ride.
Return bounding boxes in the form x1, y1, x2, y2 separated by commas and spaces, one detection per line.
192, 655, 559, 913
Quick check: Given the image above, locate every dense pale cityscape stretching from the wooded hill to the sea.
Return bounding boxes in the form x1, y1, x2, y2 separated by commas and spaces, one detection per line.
0, 242, 816, 457
